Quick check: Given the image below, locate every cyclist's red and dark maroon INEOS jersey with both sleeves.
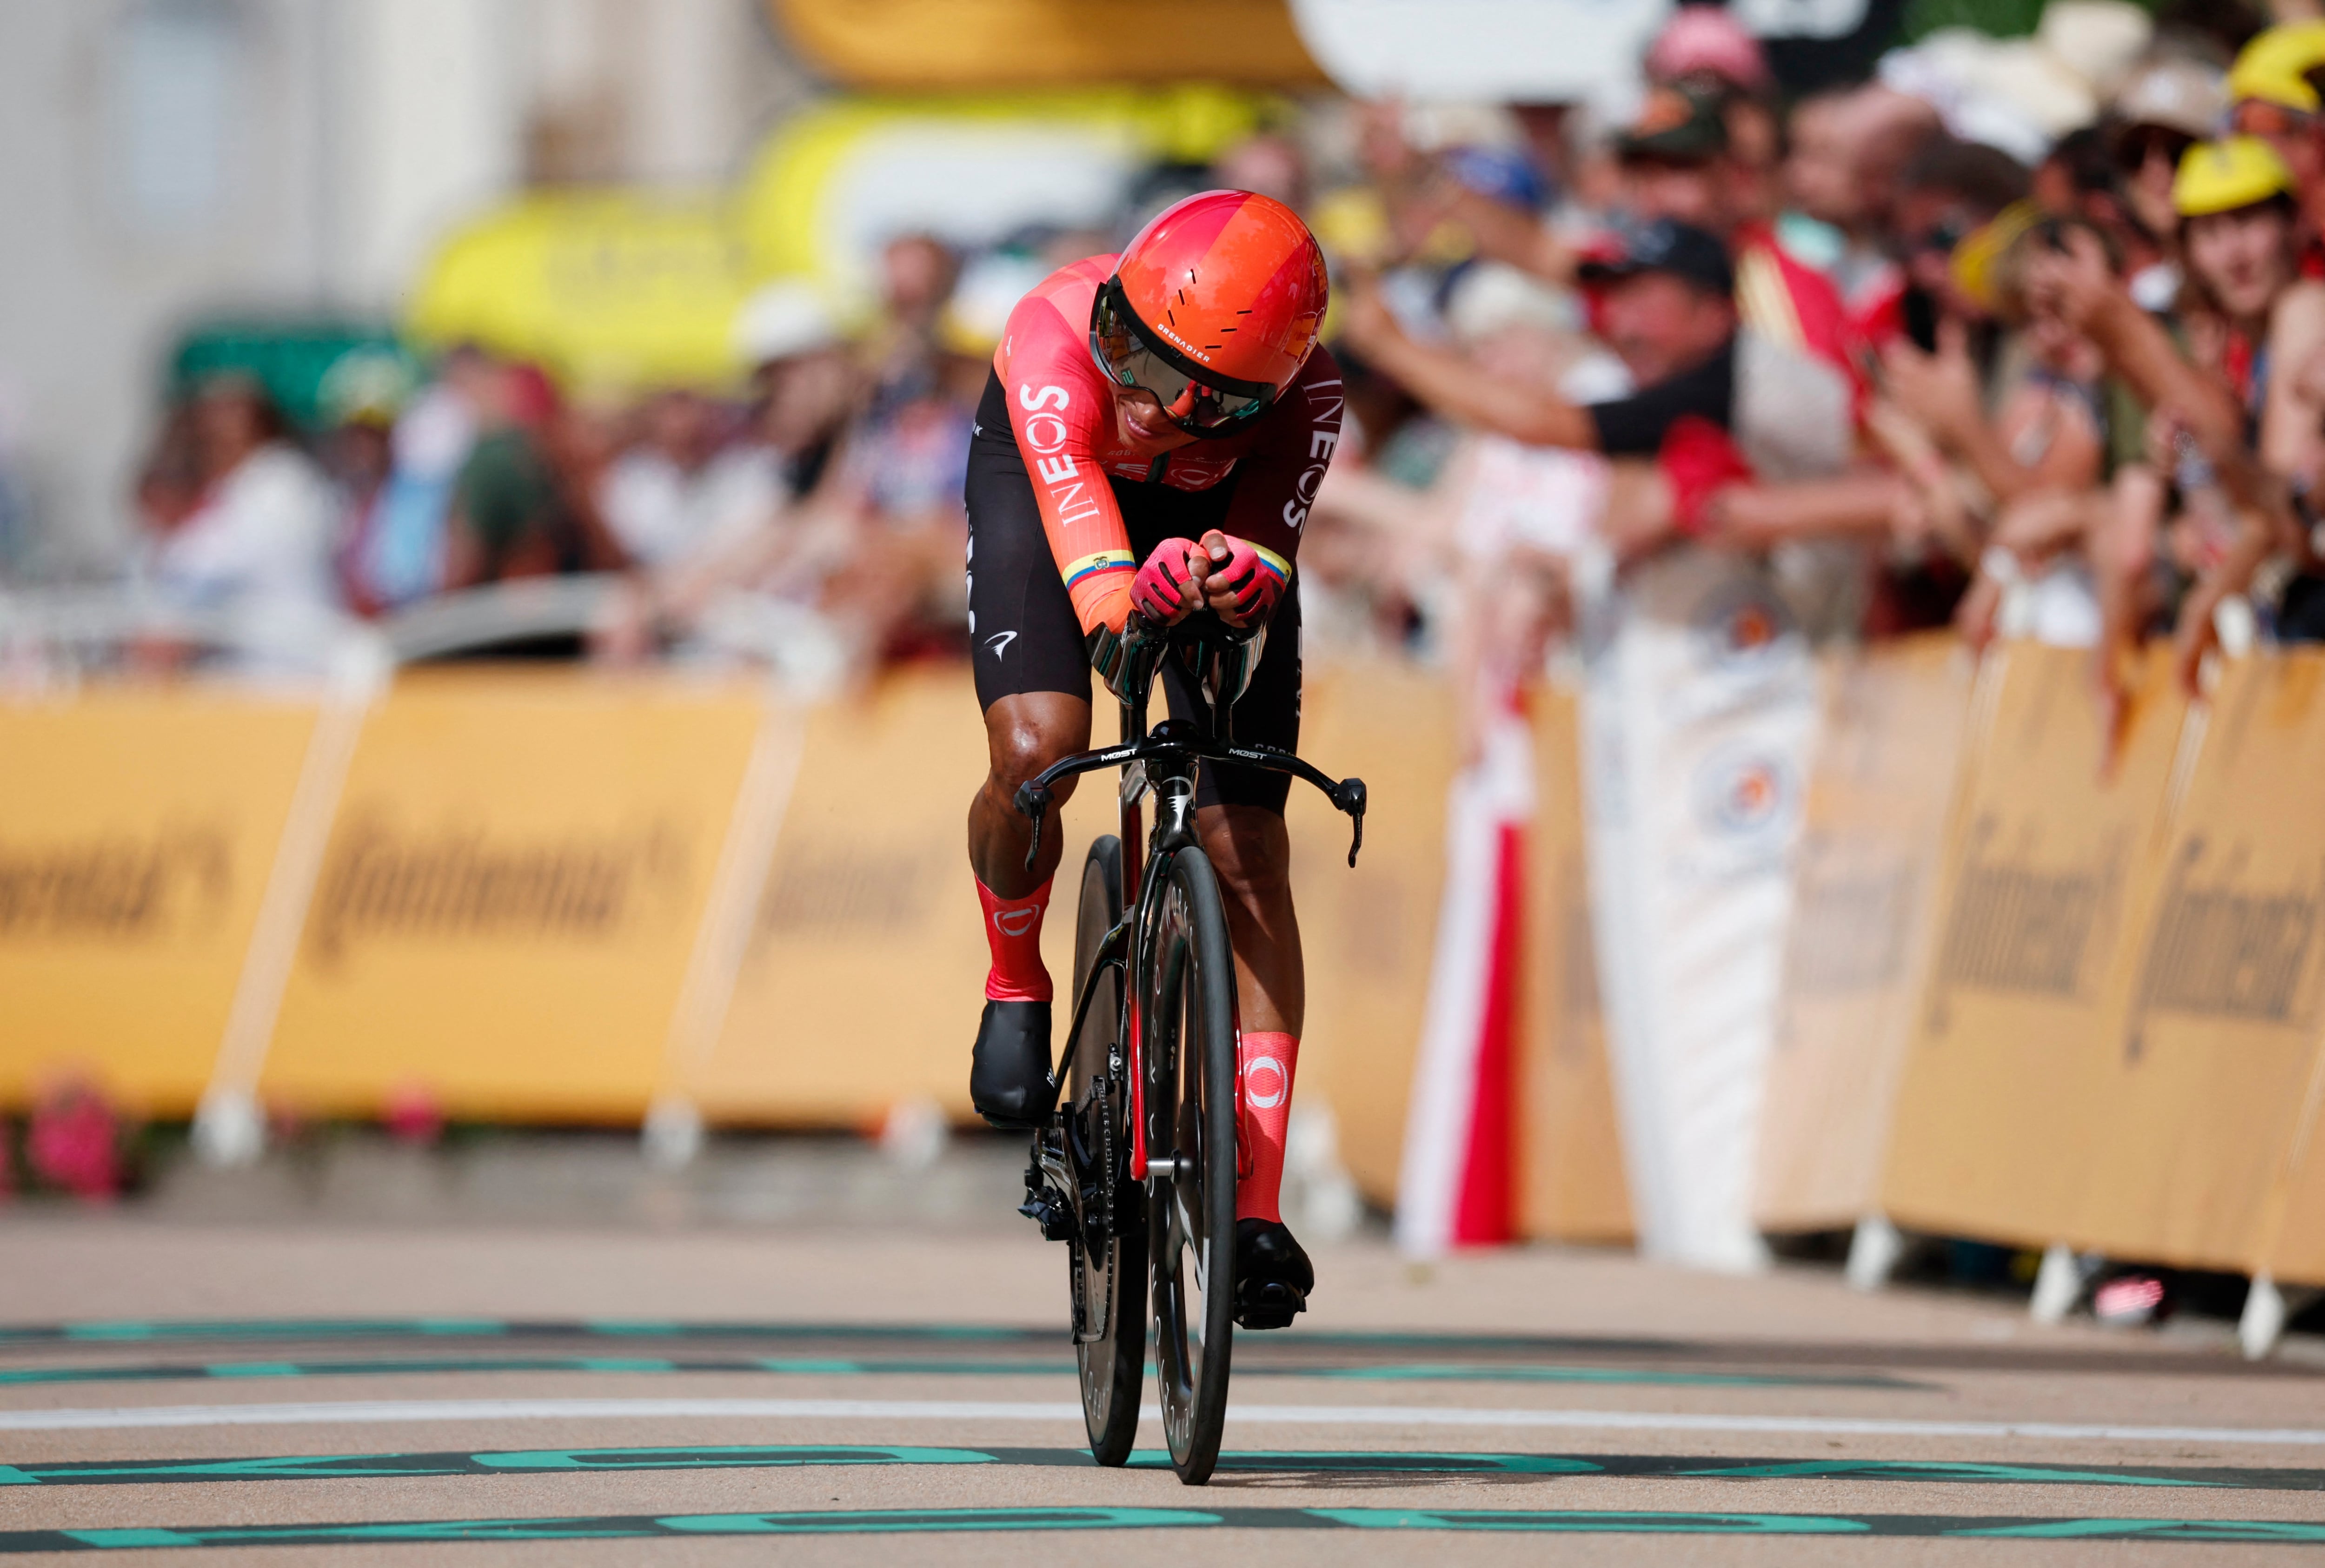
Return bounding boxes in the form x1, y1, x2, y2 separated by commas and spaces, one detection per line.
993, 256, 1344, 632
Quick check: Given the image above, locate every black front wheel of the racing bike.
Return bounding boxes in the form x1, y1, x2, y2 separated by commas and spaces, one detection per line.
1142, 850, 1235, 1487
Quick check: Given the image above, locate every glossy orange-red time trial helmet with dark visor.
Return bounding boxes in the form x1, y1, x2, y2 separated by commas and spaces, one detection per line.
1090, 191, 1325, 434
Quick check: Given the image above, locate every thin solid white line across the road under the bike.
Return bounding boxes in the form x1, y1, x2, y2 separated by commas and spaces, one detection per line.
0, 1398, 2325, 1447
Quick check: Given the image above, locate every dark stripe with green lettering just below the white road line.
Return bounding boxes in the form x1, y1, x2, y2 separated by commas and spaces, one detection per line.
0, 1442, 2325, 1491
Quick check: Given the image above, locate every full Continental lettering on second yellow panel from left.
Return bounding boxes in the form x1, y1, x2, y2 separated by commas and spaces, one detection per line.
307, 813, 691, 966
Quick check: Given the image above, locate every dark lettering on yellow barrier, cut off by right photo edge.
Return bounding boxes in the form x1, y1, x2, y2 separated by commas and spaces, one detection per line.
2125, 834, 2325, 1062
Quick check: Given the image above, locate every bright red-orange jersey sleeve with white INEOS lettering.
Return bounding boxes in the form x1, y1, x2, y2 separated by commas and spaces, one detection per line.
993, 256, 1137, 634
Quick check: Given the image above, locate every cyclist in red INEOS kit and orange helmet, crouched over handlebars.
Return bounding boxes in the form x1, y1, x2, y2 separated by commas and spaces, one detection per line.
965, 191, 1342, 1329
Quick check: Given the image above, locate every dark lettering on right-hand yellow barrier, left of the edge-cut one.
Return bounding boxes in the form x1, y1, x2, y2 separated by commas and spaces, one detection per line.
1930, 813, 2123, 1029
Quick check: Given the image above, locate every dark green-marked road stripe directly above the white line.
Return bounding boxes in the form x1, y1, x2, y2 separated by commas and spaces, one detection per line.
0, 1356, 1930, 1389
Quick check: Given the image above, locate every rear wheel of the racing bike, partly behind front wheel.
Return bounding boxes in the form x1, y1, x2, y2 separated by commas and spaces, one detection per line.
1063, 834, 1146, 1466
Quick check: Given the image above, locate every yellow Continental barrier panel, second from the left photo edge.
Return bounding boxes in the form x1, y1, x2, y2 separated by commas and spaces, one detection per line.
260, 669, 765, 1122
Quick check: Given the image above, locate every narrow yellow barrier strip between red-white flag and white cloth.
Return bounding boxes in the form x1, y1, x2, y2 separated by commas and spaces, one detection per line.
1518, 685, 1632, 1240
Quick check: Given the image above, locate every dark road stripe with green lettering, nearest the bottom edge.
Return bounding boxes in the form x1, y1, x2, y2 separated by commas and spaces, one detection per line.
0, 1508, 2325, 1554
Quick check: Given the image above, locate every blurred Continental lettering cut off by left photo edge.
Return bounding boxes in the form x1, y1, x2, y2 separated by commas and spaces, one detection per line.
0, 827, 235, 943
